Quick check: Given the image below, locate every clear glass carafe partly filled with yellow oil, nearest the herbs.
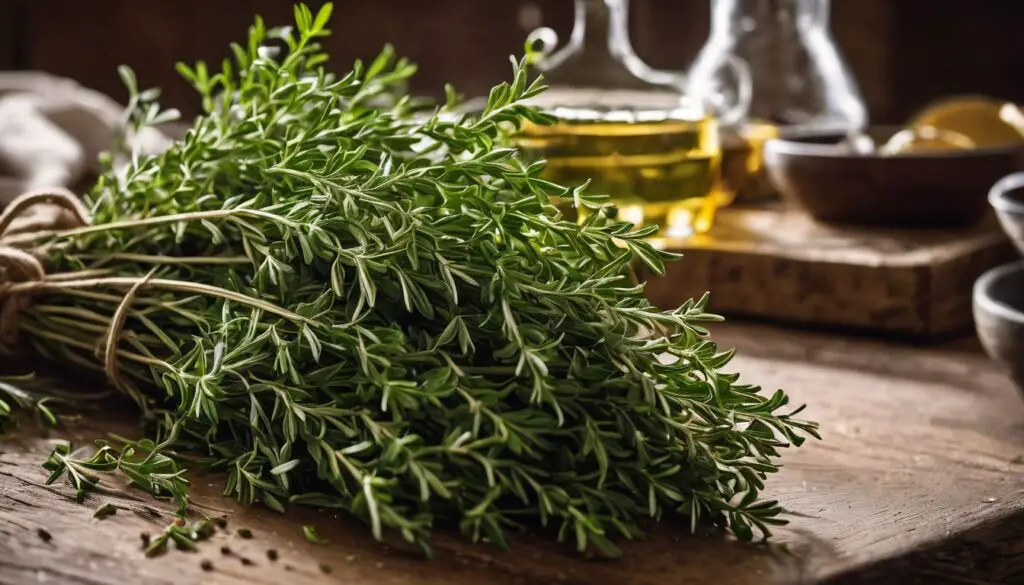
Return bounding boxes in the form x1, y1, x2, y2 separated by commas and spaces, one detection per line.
517, 0, 729, 236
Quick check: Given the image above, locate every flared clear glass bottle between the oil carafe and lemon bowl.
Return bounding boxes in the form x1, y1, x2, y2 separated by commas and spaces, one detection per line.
686, 0, 867, 200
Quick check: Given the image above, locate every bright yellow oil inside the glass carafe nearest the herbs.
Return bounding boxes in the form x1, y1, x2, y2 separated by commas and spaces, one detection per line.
516, 91, 731, 237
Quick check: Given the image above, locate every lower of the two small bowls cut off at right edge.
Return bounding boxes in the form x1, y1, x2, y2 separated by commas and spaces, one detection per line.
974, 262, 1024, 393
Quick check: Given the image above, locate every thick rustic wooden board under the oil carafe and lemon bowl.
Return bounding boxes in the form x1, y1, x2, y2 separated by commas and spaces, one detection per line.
647, 207, 1014, 340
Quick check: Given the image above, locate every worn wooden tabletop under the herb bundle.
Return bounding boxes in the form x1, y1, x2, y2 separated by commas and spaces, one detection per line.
0, 325, 1024, 585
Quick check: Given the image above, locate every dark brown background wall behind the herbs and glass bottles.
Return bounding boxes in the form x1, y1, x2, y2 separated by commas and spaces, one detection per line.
0, 0, 1024, 123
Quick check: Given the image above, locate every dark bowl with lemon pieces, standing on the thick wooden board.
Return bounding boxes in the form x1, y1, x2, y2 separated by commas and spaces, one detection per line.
765, 127, 1024, 227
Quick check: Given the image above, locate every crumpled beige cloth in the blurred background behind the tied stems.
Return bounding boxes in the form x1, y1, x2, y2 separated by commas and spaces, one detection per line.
0, 72, 171, 234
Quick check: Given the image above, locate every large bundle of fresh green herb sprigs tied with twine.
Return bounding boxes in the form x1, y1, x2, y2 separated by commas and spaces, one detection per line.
14, 4, 816, 554
